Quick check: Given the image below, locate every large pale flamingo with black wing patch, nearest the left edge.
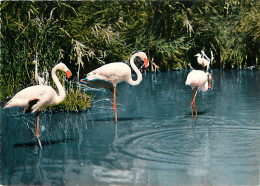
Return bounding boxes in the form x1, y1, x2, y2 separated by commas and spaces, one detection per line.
5, 63, 72, 149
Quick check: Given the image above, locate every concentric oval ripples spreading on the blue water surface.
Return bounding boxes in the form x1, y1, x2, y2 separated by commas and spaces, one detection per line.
115, 118, 260, 166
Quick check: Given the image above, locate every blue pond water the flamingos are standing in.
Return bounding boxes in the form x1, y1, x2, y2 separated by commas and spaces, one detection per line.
0, 70, 260, 185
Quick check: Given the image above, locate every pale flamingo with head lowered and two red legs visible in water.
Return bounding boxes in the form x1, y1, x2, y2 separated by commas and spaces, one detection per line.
185, 70, 212, 119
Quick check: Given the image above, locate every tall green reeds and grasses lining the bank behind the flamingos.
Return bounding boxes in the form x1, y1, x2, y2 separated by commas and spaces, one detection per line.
0, 0, 260, 109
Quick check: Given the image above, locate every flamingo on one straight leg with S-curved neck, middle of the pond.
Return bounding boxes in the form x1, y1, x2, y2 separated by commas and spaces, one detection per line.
80, 51, 149, 123
